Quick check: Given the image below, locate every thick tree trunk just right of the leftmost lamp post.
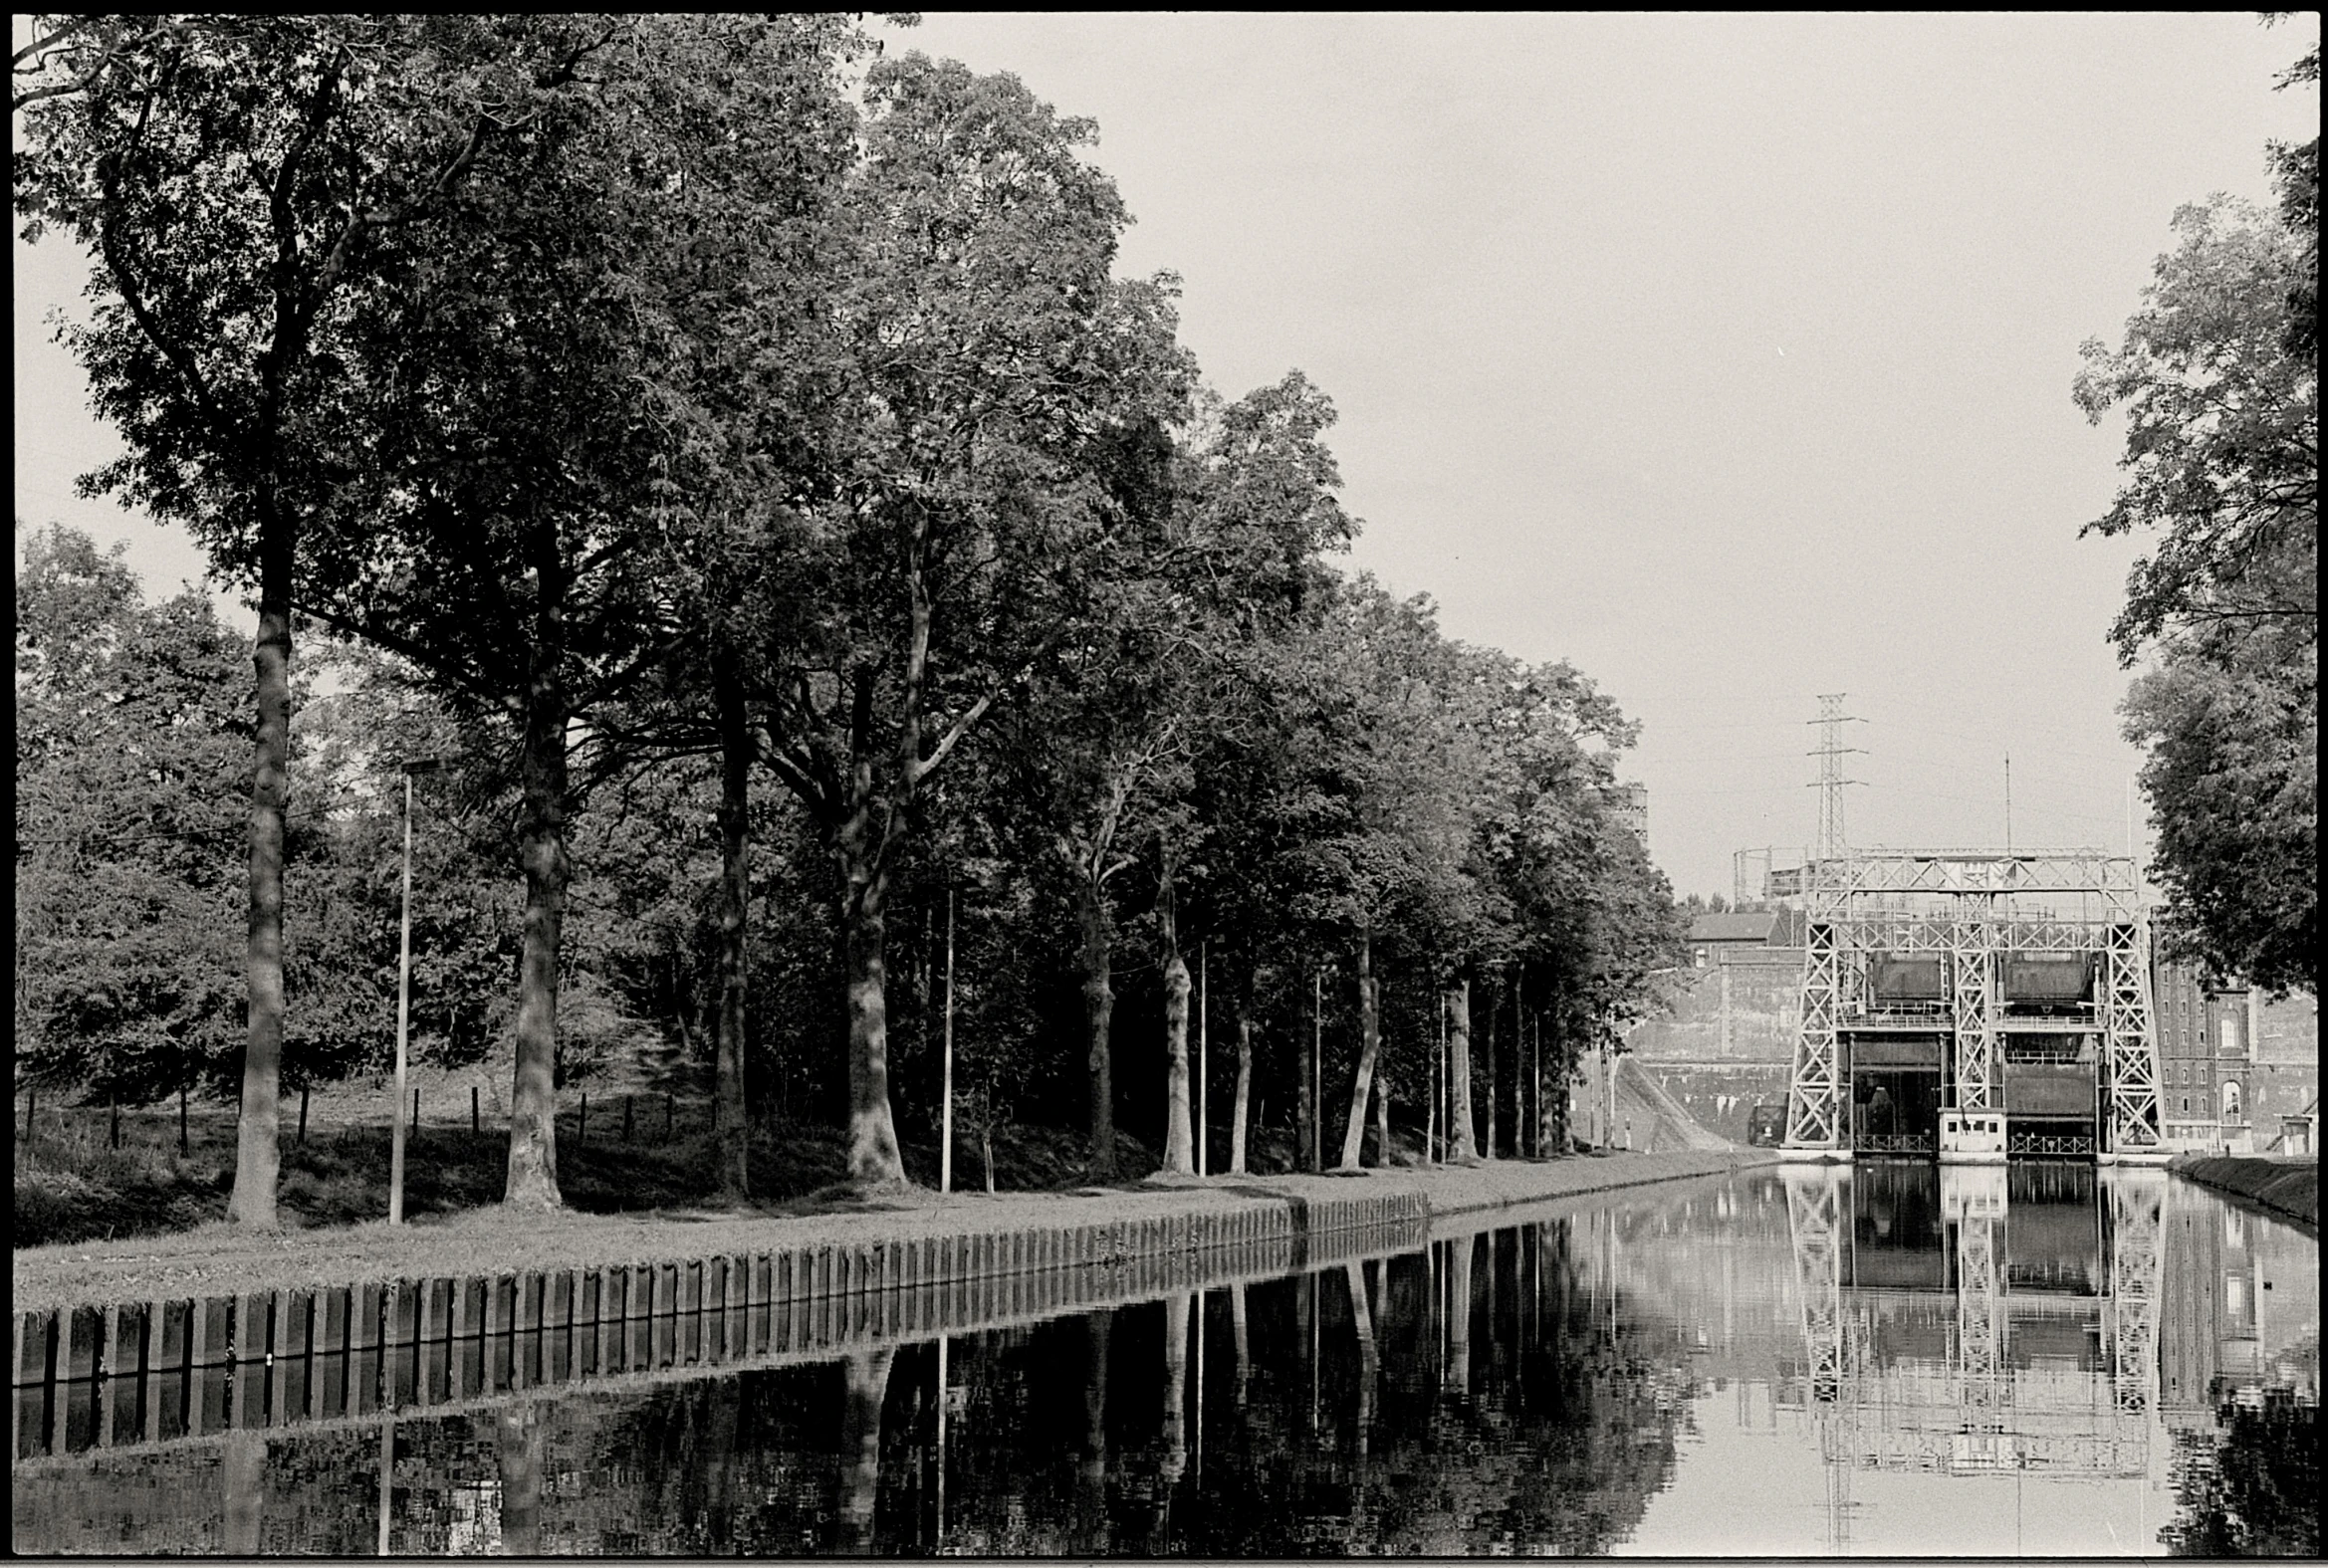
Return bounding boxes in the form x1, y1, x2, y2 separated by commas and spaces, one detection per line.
501, 549, 573, 1210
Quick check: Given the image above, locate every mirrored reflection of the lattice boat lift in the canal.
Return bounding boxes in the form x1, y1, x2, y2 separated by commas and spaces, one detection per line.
1781, 1163, 2168, 1549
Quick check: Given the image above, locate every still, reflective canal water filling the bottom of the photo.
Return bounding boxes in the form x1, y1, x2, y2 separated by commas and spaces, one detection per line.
12, 1163, 2319, 1556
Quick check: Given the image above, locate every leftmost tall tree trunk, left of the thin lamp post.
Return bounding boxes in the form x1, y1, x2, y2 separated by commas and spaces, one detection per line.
226, 519, 291, 1231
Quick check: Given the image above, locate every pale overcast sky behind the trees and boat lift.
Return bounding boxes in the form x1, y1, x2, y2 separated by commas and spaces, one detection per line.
16, 14, 2319, 893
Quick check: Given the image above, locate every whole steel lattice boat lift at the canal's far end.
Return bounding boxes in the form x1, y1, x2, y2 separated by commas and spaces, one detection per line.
1781, 849, 2168, 1163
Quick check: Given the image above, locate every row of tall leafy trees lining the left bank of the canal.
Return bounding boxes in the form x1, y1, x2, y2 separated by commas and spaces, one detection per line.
16, 16, 1676, 1224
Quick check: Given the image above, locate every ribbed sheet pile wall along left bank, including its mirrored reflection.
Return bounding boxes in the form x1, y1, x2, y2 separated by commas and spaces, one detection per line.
12, 1191, 1430, 1463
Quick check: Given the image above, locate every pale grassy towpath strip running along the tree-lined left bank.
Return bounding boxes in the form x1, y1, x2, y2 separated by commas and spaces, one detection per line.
14, 1147, 1776, 1312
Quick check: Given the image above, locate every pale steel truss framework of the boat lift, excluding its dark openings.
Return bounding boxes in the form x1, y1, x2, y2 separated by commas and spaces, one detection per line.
1785, 849, 2165, 1154
